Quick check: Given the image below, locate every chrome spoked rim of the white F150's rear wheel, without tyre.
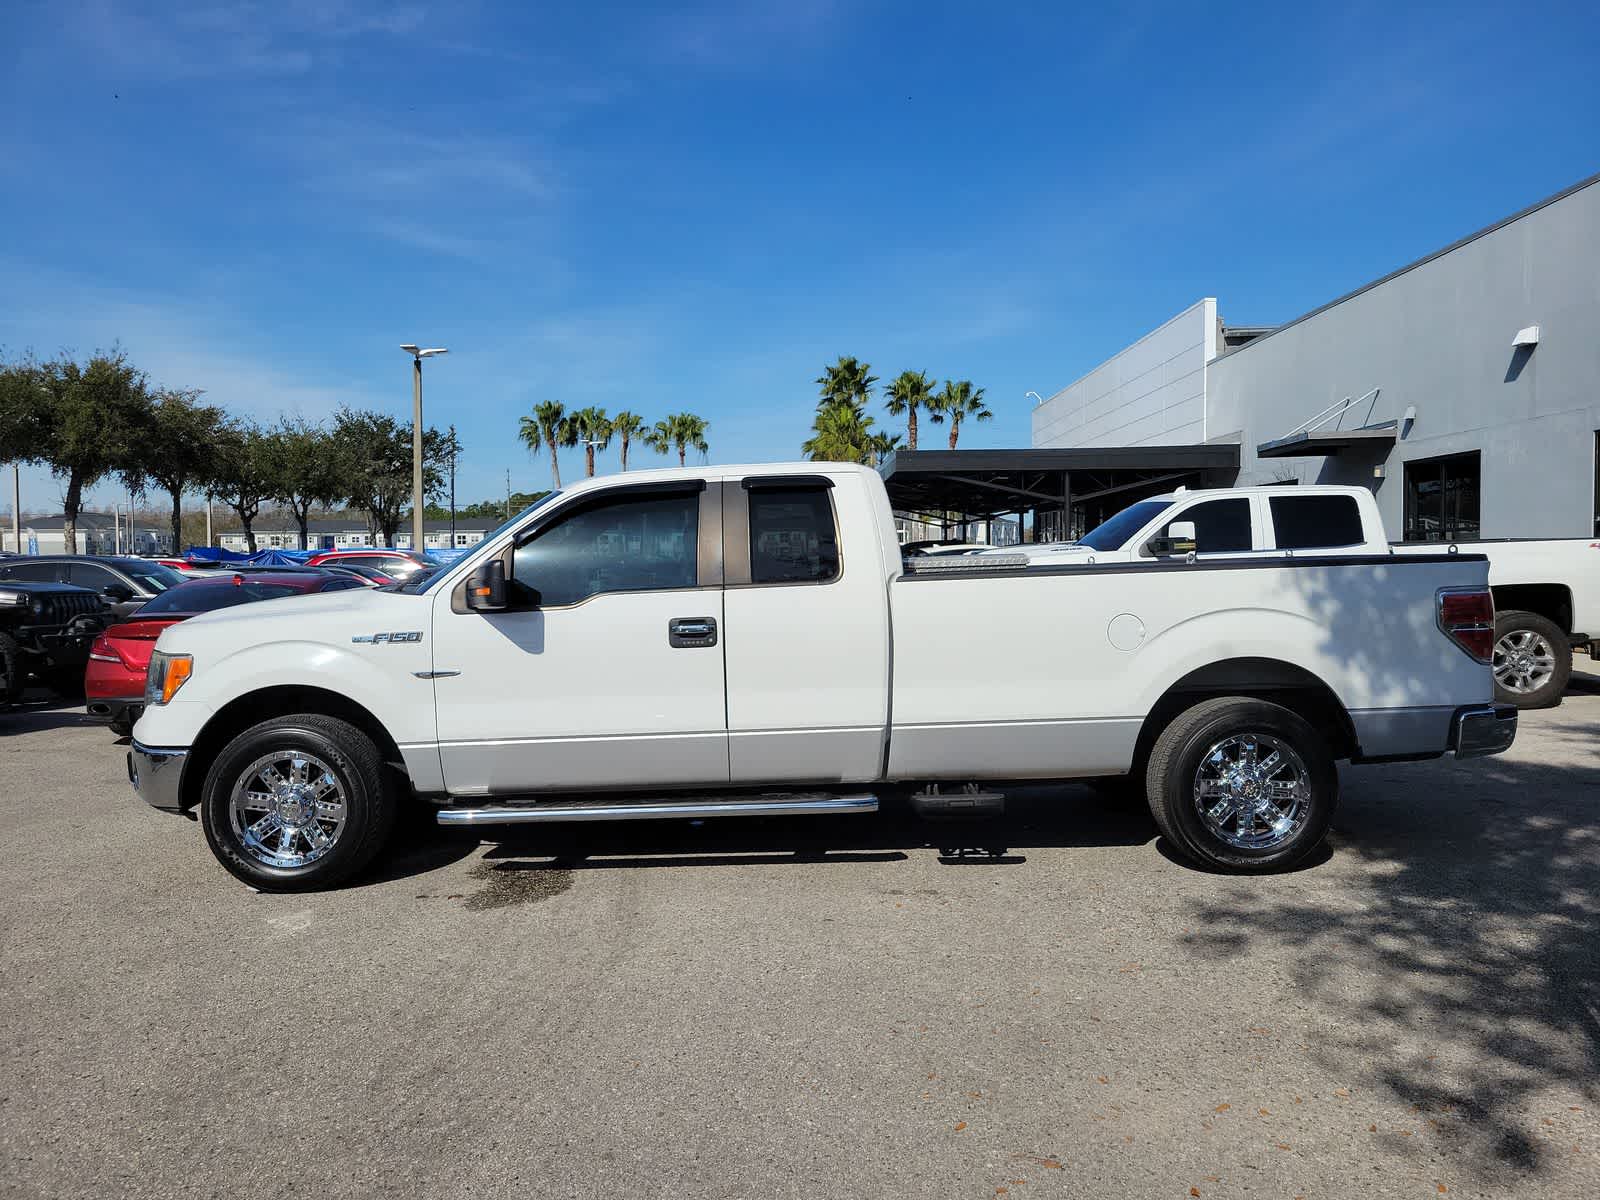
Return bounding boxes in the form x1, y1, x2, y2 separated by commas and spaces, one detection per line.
1194, 733, 1312, 850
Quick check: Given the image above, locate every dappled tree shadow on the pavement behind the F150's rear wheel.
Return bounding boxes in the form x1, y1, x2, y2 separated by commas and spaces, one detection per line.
1189, 729, 1600, 1184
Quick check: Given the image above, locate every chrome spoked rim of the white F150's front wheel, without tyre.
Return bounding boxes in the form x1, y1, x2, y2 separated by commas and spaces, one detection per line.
229, 750, 346, 869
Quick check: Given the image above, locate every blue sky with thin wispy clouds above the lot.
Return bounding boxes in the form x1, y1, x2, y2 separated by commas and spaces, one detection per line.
0, 0, 1600, 509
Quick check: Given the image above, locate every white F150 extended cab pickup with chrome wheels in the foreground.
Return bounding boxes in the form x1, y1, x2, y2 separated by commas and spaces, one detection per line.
128, 464, 1517, 890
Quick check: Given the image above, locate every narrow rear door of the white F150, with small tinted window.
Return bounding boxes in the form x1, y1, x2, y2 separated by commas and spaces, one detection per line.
723, 475, 890, 784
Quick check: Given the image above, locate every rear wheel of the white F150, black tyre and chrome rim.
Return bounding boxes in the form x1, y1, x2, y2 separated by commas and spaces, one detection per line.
1146, 696, 1339, 874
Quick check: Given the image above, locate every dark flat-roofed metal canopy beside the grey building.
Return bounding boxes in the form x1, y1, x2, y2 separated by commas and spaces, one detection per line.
878, 443, 1238, 531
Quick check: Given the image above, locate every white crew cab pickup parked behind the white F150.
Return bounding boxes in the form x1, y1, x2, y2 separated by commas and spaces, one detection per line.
998, 485, 1600, 709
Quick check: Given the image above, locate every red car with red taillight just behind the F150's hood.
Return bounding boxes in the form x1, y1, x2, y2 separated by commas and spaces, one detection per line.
83, 571, 368, 738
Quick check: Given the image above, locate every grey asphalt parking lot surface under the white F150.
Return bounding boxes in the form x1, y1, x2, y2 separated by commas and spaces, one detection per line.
0, 672, 1600, 1200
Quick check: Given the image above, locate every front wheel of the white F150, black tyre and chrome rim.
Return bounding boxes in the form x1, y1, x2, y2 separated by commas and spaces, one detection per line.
200, 714, 397, 891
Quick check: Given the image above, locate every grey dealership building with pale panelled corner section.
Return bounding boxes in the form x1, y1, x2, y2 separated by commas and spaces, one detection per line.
1024, 176, 1600, 541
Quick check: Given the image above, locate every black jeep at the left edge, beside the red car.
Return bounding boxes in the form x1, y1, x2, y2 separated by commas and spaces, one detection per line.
0, 579, 109, 706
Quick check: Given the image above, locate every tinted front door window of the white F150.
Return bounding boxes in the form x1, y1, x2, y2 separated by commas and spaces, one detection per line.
509, 494, 699, 608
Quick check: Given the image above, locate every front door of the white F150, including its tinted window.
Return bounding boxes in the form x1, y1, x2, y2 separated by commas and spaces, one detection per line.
434, 480, 728, 795
